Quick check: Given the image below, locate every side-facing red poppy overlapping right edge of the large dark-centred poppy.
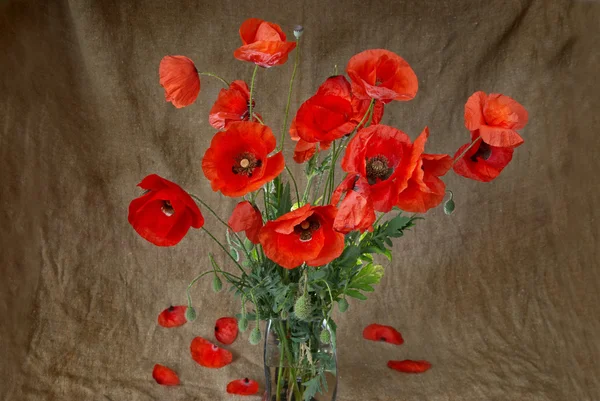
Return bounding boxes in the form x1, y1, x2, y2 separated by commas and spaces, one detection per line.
397, 127, 452, 213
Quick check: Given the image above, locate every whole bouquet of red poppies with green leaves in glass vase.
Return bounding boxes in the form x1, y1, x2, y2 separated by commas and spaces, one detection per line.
129, 18, 528, 401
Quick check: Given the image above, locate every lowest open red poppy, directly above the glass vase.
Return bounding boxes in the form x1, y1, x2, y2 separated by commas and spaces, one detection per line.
259, 204, 344, 269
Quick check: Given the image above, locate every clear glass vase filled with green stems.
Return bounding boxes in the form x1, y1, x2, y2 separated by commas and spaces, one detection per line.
263, 319, 337, 401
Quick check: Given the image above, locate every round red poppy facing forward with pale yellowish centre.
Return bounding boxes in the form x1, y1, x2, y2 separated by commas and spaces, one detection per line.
202, 121, 285, 197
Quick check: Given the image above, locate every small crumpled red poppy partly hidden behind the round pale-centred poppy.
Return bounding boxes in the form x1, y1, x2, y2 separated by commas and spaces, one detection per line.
208, 81, 260, 130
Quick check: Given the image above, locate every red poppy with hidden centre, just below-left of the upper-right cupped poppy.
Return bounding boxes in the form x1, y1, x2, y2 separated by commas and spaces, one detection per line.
290, 75, 383, 163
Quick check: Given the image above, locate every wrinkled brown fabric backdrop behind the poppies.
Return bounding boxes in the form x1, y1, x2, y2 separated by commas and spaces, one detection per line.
0, 0, 600, 401
